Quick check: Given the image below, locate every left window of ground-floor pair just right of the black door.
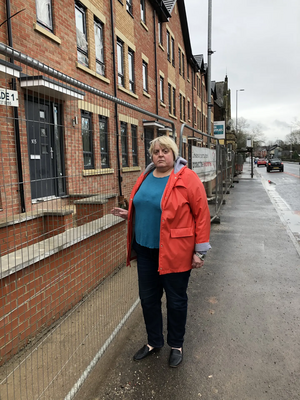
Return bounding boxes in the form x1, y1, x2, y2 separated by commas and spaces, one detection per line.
81, 111, 94, 169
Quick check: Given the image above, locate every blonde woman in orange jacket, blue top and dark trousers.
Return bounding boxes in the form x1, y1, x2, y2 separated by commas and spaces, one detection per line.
112, 136, 211, 367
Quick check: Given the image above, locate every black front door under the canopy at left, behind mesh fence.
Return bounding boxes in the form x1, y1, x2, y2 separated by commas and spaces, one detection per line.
26, 100, 64, 200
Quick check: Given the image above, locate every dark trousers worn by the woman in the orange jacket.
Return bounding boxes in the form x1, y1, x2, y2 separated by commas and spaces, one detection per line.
134, 242, 191, 348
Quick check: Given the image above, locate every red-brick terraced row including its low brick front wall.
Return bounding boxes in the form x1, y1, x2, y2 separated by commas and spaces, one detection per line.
0, 0, 214, 368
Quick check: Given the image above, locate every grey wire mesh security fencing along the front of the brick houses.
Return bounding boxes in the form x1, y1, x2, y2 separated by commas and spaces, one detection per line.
0, 44, 234, 400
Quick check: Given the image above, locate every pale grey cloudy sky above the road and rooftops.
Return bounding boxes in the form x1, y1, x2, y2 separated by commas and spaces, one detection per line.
185, 0, 300, 144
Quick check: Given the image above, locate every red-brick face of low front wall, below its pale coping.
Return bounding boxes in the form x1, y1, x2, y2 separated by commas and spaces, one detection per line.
0, 221, 126, 365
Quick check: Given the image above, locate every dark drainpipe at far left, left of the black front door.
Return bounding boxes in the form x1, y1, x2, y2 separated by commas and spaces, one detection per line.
6, 0, 26, 213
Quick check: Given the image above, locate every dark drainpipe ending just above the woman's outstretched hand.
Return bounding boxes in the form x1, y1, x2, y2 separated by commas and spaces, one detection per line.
110, 0, 123, 203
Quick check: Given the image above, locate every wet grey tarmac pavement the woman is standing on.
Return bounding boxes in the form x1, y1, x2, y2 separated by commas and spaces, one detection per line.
76, 164, 300, 400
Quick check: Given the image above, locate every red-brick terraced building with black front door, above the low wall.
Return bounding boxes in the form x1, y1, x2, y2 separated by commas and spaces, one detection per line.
0, 0, 213, 214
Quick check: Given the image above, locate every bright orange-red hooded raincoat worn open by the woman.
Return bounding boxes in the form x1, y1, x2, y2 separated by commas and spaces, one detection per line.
127, 159, 211, 275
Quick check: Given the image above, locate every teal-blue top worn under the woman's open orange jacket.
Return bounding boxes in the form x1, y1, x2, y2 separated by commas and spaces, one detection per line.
133, 171, 169, 249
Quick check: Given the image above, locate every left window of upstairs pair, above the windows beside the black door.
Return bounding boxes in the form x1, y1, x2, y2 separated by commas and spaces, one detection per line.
75, 3, 89, 66
